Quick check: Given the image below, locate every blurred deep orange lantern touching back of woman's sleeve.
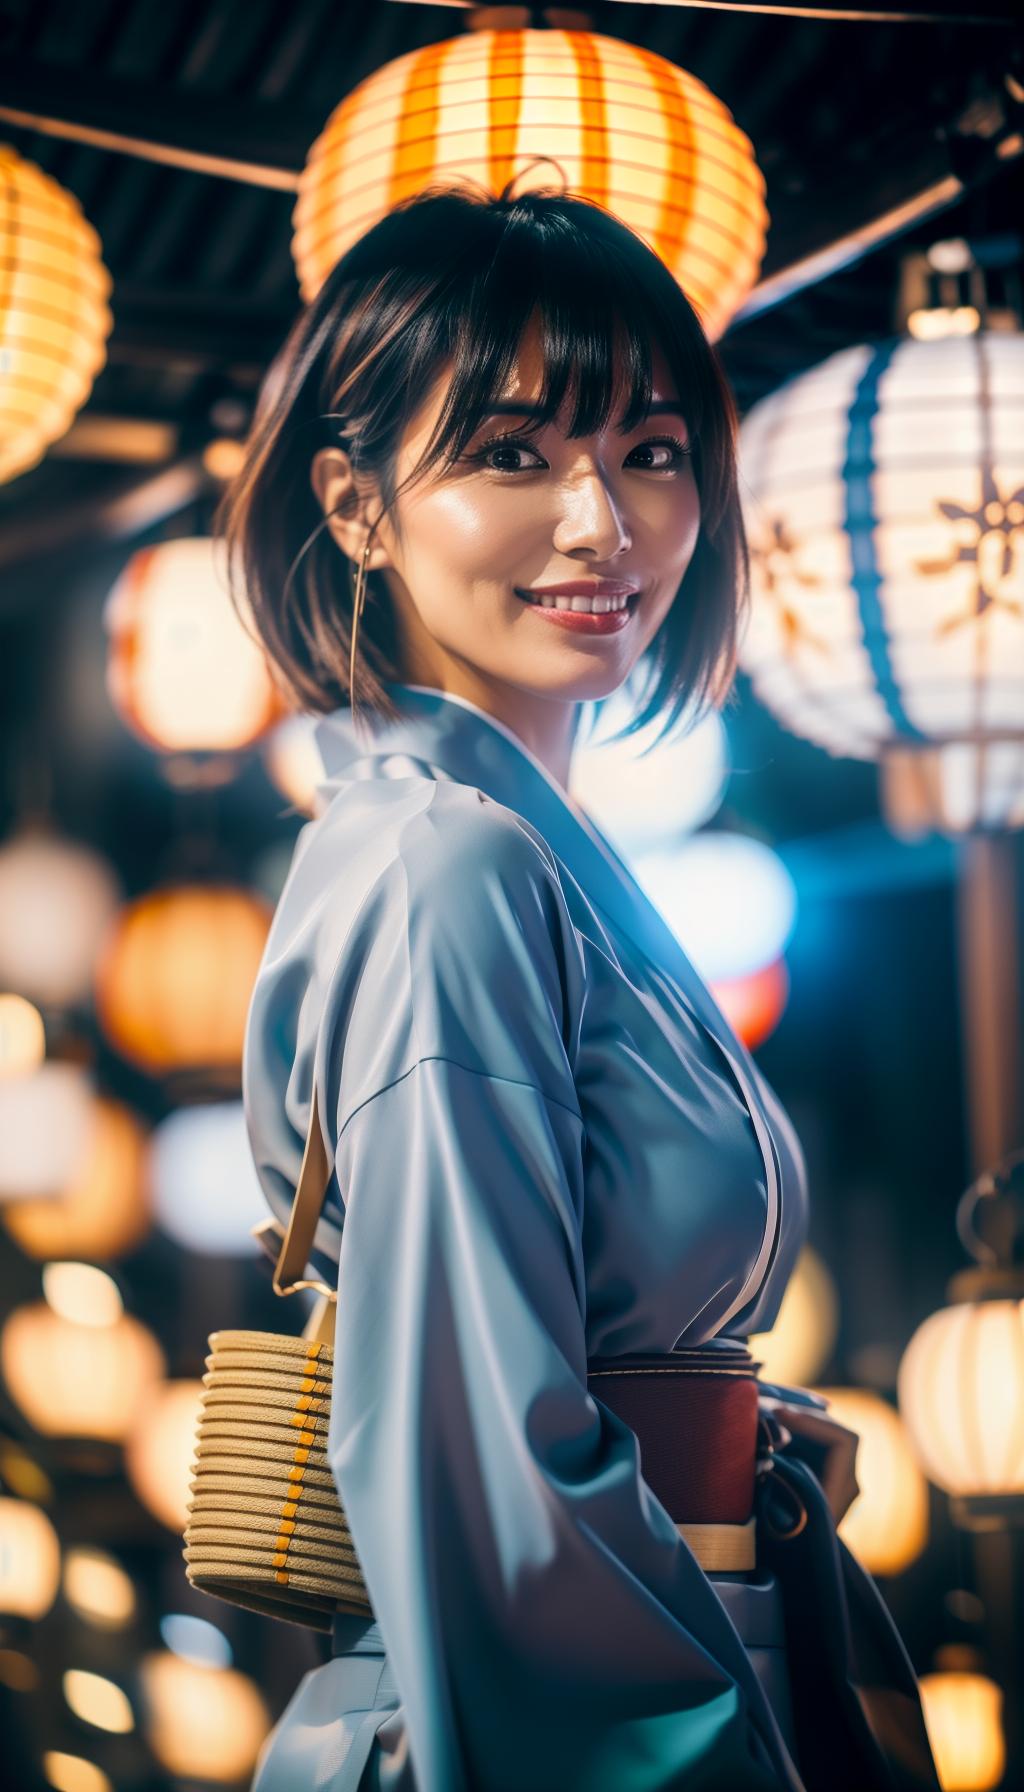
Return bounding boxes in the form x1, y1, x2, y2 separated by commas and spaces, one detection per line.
97, 885, 273, 1073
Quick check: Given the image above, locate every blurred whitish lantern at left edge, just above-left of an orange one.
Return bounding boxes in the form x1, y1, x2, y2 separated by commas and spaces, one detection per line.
0, 1063, 93, 1201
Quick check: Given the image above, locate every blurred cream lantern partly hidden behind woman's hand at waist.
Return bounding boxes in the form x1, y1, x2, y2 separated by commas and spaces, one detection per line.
814, 1387, 927, 1575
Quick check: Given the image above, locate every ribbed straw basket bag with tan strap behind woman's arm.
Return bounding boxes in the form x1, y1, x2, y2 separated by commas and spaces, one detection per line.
183, 1088, 373, 1631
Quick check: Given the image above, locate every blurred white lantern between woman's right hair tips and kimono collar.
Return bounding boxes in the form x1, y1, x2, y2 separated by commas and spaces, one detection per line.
568, 688, 728, 855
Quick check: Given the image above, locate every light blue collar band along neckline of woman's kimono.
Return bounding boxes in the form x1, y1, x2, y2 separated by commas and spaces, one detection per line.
314, 683, 780, 1326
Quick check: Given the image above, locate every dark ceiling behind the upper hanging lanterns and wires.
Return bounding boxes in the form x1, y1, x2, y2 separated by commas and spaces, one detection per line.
0, 0, 1024, 613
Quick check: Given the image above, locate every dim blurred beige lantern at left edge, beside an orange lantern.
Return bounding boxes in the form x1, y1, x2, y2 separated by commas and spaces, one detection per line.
0, 828, 120, 1007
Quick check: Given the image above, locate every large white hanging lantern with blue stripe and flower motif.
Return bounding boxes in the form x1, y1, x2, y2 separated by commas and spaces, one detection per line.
739, 332, 1024, 833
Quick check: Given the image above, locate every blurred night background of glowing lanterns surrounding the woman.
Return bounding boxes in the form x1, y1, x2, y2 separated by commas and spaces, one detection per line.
0, 0, 1024, 1792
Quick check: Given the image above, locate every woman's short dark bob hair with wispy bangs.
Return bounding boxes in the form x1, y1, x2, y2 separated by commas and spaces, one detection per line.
217, 169, 750, 738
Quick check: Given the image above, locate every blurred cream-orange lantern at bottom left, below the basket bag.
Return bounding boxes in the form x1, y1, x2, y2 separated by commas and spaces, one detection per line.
142, 1652, 271, 1785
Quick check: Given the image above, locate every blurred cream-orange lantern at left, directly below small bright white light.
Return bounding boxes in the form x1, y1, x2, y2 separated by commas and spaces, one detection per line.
0, 1301, 165, 1443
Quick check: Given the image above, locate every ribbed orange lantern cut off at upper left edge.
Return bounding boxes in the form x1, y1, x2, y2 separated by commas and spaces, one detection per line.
0, 143, 113, 484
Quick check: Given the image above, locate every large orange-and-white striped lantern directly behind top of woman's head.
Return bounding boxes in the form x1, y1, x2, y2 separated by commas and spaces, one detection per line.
292, 30, 768, 340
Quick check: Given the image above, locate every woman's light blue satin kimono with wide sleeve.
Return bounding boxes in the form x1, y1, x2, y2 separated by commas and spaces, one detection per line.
244, 685, 807, 1792
